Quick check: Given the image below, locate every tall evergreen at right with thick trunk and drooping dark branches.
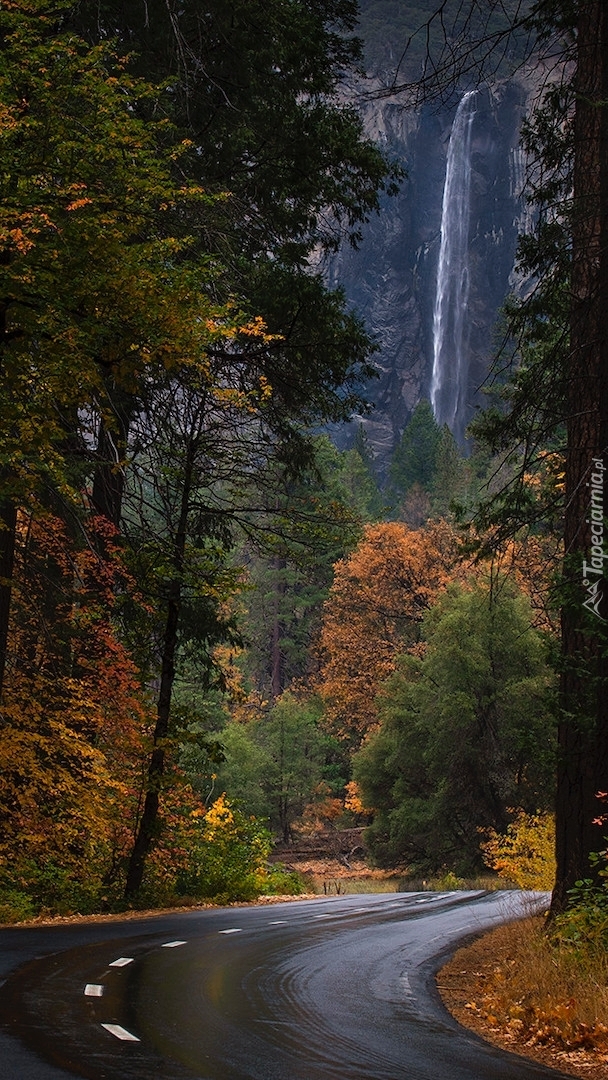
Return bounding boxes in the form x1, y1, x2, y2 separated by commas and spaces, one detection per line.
382, 0, 608, 915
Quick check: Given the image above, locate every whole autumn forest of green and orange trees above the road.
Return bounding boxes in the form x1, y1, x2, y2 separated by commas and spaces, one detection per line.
0, 0, 608, 937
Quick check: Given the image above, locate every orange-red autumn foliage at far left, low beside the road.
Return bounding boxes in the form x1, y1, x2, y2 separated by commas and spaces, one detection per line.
0, 514, 149, 878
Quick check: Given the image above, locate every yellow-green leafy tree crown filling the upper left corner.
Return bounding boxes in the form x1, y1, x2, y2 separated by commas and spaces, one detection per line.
0, 0, 235, 691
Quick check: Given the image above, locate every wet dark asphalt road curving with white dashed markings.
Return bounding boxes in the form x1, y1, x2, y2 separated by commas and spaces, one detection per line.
0, 893, 574, 1080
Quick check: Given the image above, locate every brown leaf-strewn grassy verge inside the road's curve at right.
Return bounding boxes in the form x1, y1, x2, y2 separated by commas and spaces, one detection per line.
437, 916, 608, 1062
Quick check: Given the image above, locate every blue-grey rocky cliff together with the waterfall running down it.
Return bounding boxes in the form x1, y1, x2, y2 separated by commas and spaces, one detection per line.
327, 72, 536, 464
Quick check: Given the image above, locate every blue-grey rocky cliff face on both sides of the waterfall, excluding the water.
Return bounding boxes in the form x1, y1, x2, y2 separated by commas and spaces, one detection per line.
330, 80, 535, 470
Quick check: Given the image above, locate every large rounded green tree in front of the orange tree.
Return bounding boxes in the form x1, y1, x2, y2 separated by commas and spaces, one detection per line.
353, 580, 554, 873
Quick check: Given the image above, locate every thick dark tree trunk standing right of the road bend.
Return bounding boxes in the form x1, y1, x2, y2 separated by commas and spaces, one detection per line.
551, 0, 608, 915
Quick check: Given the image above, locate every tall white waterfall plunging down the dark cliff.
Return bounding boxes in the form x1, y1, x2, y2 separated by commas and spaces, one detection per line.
431, 91, 476, 443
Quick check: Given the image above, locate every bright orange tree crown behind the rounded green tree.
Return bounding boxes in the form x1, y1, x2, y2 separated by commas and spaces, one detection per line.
320, 522, 458, 743
